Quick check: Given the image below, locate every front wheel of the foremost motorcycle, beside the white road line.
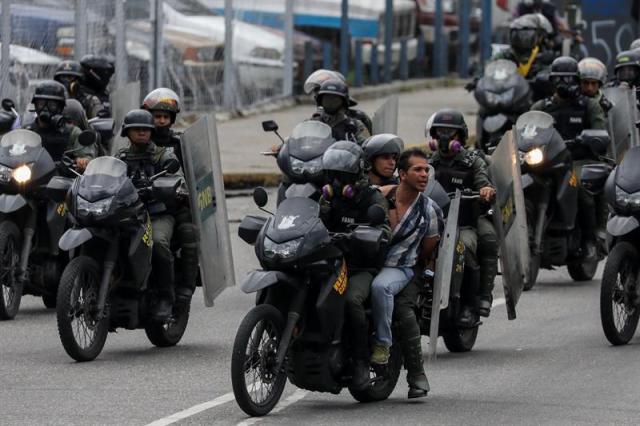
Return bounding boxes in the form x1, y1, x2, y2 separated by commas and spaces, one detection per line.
231, 304, 287, 416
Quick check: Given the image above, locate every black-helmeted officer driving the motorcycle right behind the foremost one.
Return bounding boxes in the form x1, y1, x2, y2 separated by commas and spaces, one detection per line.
311, 80, 371, 145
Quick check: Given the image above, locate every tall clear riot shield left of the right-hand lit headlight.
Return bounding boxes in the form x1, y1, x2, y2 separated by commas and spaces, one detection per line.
489, 131, 529, 320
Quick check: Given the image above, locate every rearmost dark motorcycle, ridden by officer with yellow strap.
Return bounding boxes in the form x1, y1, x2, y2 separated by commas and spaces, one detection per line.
473, 59, 531, 154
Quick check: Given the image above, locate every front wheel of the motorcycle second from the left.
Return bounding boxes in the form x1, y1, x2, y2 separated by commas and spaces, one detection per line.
56, 256, 109, 362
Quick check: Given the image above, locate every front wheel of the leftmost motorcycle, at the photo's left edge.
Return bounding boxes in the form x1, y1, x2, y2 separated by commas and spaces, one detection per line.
0, 221, 23, 320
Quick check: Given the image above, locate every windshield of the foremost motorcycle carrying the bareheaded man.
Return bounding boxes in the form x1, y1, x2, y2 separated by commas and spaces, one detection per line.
267, 197, 322, 243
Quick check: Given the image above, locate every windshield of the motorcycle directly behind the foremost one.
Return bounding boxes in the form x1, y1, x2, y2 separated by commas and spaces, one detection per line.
287, 121, 335, 161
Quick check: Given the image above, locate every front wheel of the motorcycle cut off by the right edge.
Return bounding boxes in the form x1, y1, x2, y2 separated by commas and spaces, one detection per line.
600, 242, 640, 346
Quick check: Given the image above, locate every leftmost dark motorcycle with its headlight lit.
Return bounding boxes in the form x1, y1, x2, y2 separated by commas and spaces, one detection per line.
0, 129, 93, 320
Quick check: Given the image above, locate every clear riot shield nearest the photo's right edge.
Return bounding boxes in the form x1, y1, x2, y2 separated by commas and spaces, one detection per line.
604, 84, 640, 163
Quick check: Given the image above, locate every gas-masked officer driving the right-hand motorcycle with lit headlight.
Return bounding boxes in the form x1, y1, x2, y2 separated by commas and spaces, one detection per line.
531, 56, 606, 258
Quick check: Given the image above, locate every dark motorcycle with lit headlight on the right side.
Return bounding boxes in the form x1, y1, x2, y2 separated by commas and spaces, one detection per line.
514, 111, 610, 290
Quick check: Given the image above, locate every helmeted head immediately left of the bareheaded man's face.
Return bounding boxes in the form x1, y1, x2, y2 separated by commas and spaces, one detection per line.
362, 133, 404, 186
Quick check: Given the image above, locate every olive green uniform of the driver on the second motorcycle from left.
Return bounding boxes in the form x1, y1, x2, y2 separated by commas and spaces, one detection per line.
116, 142, 182, 302
